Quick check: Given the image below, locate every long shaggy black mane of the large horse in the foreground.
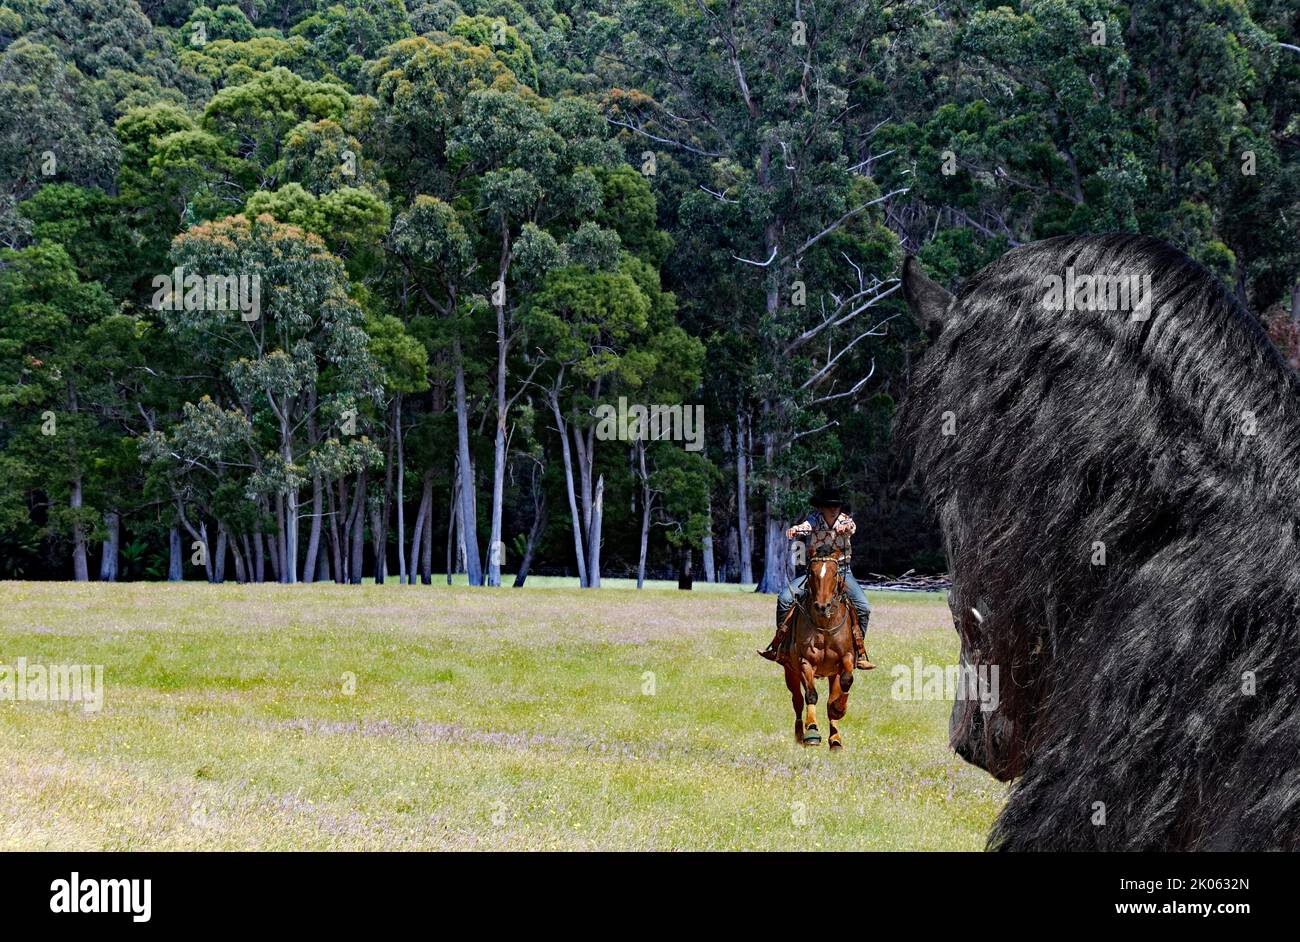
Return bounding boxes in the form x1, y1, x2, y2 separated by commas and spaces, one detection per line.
898, 235, 1300, 850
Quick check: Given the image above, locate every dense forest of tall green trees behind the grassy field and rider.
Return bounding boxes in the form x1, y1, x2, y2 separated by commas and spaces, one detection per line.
0, 0, 1300, 591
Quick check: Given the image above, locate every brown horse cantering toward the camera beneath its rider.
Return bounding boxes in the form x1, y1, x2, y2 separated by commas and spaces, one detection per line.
781, 554, 858, 751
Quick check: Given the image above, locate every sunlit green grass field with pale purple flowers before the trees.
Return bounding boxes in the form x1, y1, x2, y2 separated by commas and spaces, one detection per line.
0, 582, 1004, 850
